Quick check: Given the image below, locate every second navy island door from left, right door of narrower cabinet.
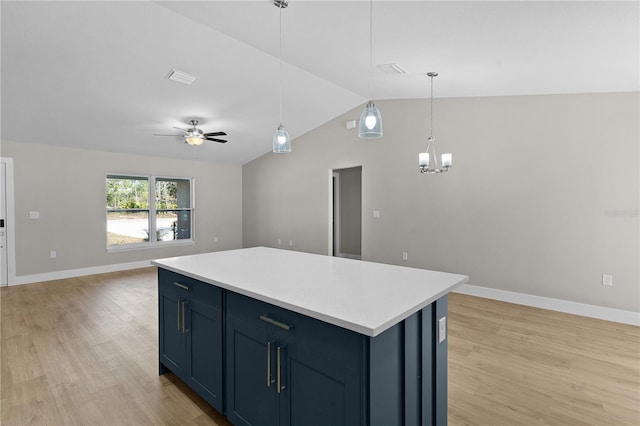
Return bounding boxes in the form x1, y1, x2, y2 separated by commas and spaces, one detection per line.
185, 299, 223, 411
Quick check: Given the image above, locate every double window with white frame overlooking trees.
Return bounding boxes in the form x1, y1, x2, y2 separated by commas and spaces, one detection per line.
106, 174, 193, 249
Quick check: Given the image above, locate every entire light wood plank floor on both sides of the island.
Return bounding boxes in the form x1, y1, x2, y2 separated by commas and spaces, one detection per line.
0, 268, 640, 426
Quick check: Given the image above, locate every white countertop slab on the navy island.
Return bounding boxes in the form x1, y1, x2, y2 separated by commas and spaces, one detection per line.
152, 247, 469, 337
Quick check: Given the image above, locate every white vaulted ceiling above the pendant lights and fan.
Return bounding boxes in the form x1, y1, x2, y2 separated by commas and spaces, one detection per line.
0, 0, 640, 164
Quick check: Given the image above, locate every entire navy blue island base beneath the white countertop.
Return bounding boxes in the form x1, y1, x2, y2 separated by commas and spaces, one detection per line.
158, 268, 447, 426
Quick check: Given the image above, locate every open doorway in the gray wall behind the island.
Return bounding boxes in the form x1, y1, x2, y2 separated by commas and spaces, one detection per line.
330, 166, 362, 259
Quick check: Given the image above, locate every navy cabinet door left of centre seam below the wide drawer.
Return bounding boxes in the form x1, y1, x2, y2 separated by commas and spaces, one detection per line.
225, 311, 278, 426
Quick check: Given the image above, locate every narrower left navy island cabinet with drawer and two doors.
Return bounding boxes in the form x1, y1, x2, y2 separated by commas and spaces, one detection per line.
158, 269, 224, 411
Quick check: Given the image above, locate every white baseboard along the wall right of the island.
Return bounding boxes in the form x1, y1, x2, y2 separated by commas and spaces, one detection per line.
455, 284, 640, 326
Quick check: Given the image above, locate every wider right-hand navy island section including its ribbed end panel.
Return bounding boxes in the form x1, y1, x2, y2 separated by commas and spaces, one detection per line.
225, 292, 447, 426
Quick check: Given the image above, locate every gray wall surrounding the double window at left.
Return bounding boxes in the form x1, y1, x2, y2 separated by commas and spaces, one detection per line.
1, 141, 242, 276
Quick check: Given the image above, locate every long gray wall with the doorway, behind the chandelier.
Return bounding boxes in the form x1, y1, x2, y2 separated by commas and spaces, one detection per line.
242, 93, 640, 312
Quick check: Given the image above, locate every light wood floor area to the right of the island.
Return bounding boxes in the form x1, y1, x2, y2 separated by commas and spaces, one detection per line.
449, 293, 640, 425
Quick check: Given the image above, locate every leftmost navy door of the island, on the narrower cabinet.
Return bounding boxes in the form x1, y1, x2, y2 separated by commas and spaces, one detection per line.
158, 283, 187, 378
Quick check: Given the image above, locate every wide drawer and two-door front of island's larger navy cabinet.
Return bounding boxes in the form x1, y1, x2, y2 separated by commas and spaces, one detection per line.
226, 294, 365, 426
